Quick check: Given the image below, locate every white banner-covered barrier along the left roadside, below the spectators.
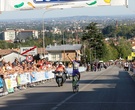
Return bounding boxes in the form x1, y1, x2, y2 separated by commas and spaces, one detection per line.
0, 67, 86, 96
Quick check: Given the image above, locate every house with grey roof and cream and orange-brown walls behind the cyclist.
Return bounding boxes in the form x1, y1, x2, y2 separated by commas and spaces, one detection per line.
46, 44, 82, 62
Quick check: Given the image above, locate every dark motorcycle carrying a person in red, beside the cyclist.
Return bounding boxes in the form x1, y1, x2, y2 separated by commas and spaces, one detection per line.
53, 71, 66, 87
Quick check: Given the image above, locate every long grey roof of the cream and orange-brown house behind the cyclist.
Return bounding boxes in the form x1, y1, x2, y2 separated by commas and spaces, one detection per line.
46, 44, 82, 51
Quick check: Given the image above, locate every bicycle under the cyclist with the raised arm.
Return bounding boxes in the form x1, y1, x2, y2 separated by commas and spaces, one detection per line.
72, 74, 79, 93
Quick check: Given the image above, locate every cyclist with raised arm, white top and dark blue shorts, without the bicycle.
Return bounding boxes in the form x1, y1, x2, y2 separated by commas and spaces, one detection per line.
67, 54, 80, 81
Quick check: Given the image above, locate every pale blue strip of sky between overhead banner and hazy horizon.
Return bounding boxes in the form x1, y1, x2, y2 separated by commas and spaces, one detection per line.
0, 0, 135, 20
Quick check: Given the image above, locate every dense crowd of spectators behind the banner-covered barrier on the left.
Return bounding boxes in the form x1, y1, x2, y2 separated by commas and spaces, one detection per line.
0, 58, 56, 91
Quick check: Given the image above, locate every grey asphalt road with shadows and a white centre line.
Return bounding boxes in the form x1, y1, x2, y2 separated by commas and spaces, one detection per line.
0, 66, 135, 110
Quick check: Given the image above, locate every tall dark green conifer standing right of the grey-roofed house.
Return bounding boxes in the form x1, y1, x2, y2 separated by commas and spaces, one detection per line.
82, 22, 104, 60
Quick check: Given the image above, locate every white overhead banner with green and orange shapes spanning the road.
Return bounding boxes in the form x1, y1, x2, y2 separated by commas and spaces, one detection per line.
0, 0, 128, 11
